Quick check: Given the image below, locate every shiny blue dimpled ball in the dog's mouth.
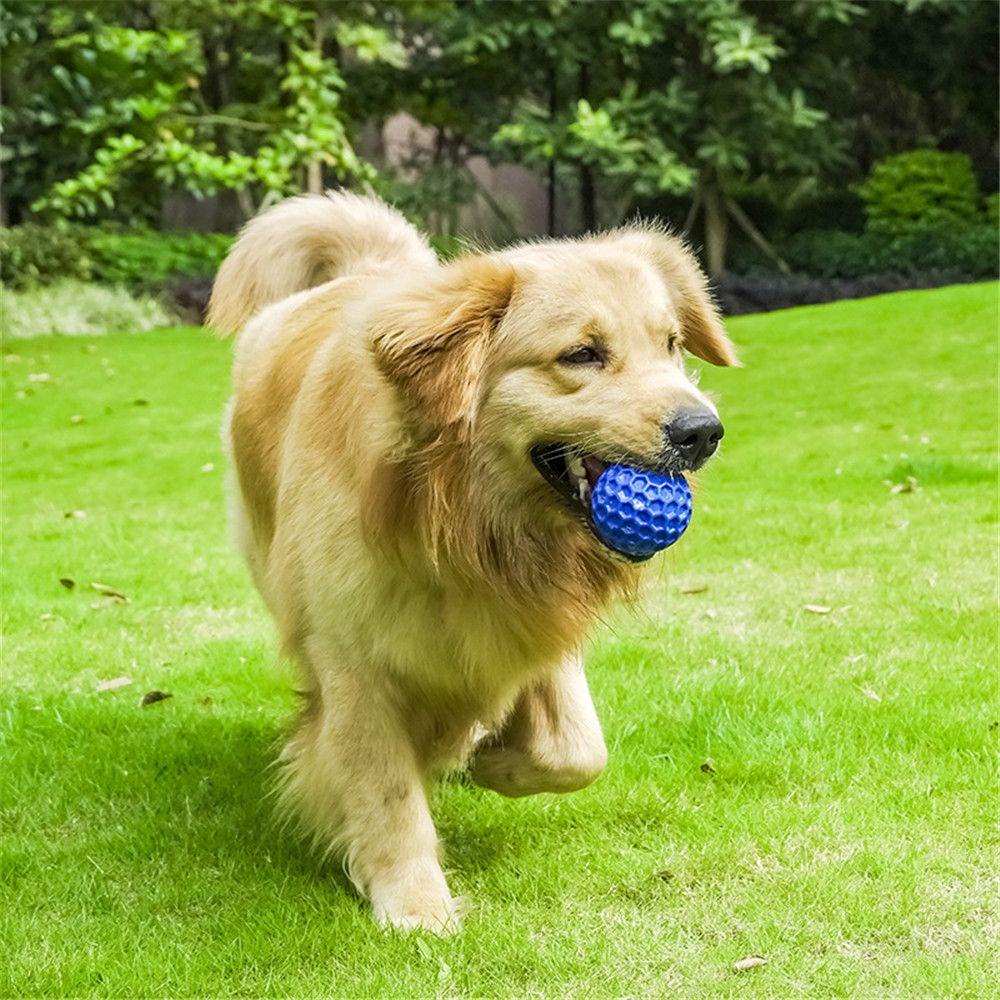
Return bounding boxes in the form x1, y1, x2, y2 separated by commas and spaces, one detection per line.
590, 465, 691, 559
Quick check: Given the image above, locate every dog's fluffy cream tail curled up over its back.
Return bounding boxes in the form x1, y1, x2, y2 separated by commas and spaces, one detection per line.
208, 191, 436, 334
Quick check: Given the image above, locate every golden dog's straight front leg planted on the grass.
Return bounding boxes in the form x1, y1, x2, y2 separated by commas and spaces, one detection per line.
285, 643, 458, 932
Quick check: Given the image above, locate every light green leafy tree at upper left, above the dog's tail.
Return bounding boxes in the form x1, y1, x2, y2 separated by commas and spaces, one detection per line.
3, 0, 405, 223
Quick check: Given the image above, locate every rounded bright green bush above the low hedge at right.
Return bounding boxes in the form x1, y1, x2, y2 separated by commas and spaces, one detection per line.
859, 149, 979, 230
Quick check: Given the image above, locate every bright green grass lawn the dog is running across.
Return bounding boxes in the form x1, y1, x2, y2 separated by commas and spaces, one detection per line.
0, 285, 1000, 998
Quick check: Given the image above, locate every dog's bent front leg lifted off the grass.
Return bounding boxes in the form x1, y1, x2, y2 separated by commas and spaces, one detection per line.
470, 656, 608, 796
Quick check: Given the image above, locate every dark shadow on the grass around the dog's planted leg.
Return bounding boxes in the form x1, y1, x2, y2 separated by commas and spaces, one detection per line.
8, 688, 540, 899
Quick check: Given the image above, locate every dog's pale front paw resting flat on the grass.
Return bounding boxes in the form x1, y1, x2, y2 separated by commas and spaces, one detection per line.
370, 861, 468, 935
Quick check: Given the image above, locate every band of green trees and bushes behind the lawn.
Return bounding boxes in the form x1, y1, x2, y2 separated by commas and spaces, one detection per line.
0, 0, 998, 311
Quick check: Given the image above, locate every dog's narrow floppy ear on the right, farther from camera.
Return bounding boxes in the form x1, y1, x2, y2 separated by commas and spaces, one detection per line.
613, 226, 739, 365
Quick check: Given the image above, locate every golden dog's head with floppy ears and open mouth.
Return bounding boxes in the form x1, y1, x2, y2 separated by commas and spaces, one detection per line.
372, 228, 736, 572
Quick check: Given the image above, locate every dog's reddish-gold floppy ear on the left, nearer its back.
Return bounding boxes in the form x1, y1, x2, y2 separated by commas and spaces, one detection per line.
371, 256, 514, 429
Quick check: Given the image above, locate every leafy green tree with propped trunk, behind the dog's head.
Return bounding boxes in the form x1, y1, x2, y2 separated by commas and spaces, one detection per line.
484, 0, 859, 274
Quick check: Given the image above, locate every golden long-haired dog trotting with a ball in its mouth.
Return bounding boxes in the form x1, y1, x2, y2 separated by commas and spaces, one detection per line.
208, 193, 736, 932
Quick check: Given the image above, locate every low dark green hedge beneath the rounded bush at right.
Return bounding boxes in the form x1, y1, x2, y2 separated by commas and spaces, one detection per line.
780, 222, 998, 280
